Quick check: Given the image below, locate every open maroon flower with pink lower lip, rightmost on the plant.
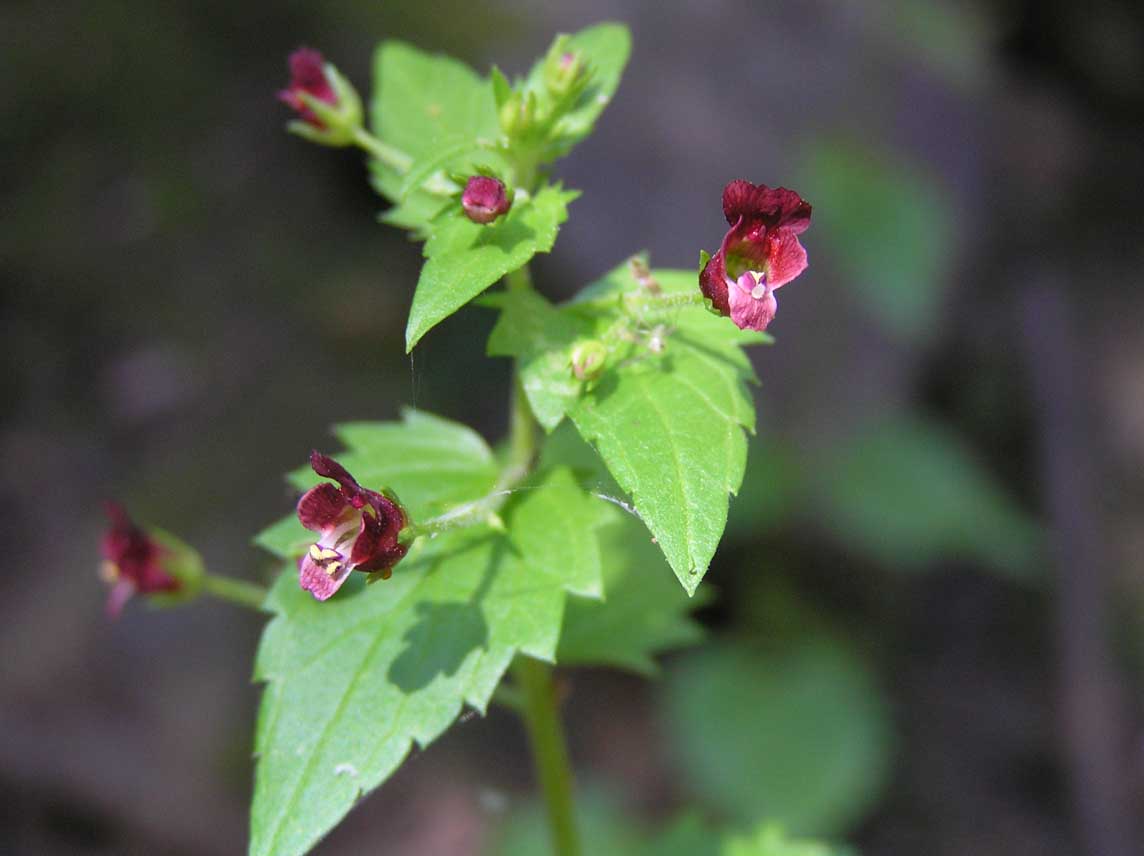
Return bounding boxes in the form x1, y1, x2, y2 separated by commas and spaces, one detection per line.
699, 180, 810, 330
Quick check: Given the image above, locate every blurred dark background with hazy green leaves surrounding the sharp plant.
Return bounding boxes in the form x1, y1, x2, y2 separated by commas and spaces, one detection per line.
0, 0, 1144, 856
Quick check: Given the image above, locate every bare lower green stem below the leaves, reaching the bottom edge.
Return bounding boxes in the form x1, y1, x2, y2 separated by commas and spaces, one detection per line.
513, 657, 580, 856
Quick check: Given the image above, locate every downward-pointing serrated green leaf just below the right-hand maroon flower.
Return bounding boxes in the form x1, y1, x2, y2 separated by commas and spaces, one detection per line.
569, 269, 768, 594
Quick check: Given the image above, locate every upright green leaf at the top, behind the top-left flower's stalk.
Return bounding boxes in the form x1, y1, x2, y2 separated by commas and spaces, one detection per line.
371, 41, 500, 236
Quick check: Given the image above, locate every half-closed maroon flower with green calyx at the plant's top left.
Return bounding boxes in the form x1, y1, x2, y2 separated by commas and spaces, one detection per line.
278, 48, 362, 145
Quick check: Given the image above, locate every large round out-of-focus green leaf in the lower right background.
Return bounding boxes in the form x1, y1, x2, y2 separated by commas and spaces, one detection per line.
665, 635, 891, 835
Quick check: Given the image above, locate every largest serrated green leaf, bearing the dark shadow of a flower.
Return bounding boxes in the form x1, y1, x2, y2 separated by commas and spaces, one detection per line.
251, 448, 601, 856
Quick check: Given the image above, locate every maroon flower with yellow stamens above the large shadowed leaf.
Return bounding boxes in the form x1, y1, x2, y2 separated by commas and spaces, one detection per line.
297, 452, 407, 601
